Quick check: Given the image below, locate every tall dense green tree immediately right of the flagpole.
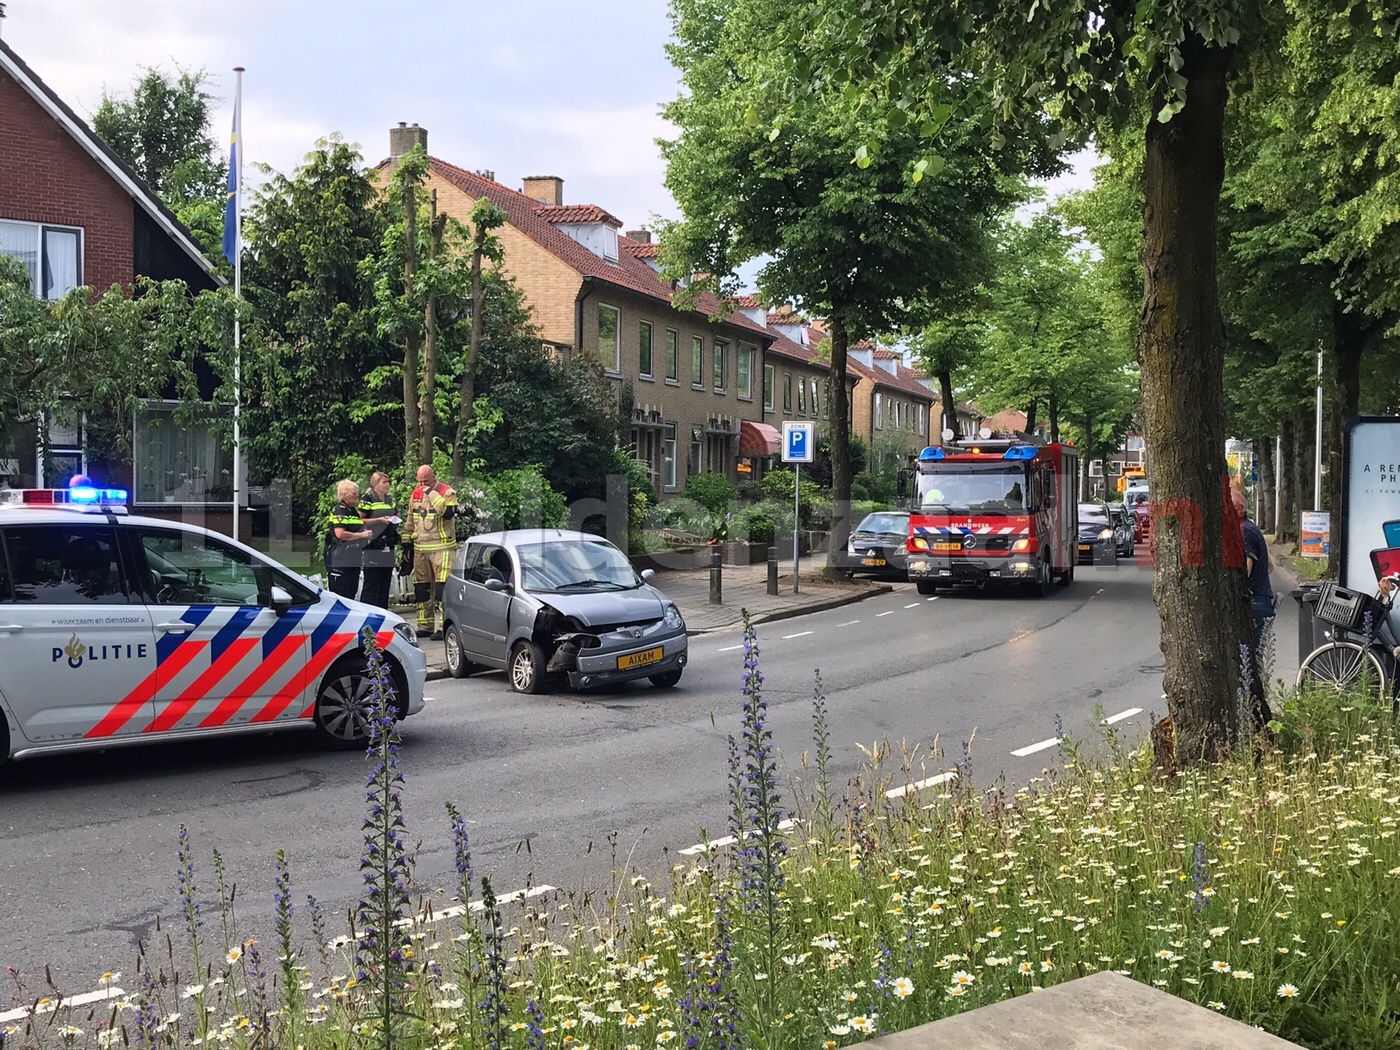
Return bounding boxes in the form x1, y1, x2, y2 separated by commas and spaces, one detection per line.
244, 139, 403, 518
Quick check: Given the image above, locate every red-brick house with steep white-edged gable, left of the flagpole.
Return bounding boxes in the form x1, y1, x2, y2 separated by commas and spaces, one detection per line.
0, 42, 221, 514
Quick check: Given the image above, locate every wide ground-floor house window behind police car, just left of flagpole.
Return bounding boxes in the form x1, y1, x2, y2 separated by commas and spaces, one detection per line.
132, 402, 234, 504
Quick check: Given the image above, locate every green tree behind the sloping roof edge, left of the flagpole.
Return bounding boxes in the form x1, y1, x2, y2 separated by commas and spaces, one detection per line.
92, 69, 228, 256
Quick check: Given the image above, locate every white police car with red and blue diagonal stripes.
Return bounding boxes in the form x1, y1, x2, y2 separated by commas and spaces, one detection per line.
0, 487, 427, 763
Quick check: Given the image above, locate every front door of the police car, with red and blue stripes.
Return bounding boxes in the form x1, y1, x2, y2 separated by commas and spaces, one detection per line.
132, 526, 307, 732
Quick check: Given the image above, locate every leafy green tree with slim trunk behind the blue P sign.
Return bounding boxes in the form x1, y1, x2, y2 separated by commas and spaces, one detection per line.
662, 0, 1052, 576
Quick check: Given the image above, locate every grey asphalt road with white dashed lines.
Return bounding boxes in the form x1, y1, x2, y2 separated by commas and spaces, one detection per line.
0, 563, 1292, 1005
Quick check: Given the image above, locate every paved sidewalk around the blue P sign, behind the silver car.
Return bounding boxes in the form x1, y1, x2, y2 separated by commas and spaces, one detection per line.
420, 554, 893, 680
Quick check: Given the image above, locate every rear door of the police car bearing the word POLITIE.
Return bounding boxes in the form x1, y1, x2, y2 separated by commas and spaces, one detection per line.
0, 514, 158, 743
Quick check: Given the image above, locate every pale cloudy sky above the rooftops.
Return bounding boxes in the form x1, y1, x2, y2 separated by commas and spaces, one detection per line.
0, 0, 1092, 250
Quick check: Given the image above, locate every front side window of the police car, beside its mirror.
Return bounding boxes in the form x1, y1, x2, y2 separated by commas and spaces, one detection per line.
137, 529, 275, 606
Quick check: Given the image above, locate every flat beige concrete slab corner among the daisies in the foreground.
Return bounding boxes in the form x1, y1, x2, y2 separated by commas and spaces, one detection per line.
862, 972, 1296, 1050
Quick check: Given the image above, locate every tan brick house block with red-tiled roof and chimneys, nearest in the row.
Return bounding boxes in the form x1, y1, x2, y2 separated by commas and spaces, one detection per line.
378, 125, 778, 498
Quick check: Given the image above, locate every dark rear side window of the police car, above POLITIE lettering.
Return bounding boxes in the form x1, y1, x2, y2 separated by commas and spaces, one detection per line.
4, 524, 130, 605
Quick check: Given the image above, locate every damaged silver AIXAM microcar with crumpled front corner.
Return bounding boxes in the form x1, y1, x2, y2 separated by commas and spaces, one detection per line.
442, 529, 686, 693
